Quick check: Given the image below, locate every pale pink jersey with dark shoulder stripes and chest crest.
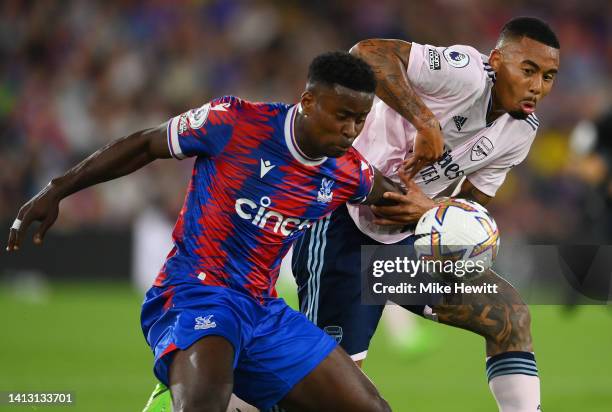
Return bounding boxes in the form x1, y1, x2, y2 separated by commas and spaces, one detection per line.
348, 43, 539, 243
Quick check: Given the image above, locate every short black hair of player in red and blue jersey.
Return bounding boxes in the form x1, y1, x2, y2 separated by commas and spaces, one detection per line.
308, 51, 376, 93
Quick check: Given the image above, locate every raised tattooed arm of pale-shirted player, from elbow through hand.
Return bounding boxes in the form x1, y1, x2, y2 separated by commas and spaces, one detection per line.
350, 39, 444, 177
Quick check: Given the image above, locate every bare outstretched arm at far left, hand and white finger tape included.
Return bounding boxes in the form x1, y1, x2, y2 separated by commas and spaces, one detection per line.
6, 124, 170, 252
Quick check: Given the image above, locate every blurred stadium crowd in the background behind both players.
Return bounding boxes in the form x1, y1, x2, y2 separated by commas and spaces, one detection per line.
0, 0, 612, 243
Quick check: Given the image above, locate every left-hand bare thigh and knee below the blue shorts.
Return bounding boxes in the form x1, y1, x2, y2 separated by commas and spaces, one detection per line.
169, 335, 234, 411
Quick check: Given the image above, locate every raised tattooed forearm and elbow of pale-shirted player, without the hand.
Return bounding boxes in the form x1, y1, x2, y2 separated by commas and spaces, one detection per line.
351, 39, 437, 129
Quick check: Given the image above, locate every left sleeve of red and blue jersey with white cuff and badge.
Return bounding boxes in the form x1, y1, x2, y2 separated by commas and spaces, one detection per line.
167, 96, 241, 159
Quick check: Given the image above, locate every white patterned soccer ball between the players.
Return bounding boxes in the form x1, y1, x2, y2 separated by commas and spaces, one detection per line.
414, 199, 499, 282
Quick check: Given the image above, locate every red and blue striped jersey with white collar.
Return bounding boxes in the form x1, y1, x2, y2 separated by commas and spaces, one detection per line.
155, 96, 374, 303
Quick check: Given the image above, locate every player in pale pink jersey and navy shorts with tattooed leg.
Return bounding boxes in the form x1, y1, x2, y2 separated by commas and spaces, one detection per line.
292, 17, 559, 412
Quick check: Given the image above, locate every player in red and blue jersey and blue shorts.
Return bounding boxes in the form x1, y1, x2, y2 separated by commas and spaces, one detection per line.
7, 52, 396, 411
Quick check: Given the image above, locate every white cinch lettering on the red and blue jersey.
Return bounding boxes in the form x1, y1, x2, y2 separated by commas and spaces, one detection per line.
235, 196, 310, 236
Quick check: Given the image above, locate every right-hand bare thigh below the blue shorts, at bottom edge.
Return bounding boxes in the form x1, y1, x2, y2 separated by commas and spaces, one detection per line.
280, 347, 388, 412
